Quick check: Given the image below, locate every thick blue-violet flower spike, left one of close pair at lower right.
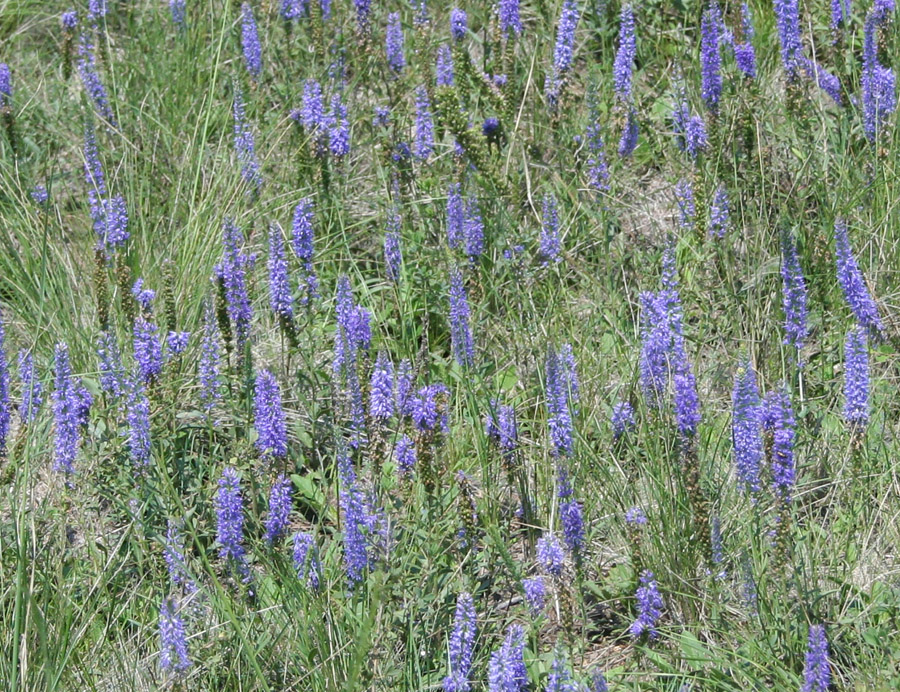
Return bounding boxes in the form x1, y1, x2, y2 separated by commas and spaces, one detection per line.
731, 361, 763, 493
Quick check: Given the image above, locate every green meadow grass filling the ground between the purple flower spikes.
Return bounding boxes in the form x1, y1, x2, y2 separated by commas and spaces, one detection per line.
0, 0, 900, 692
